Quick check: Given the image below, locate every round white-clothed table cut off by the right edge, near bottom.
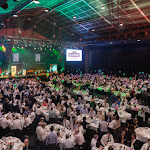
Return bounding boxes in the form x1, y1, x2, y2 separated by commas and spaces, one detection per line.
135, 127, 150, 143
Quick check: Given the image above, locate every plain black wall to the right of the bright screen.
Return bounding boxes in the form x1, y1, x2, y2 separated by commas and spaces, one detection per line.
89, 42, 150, 74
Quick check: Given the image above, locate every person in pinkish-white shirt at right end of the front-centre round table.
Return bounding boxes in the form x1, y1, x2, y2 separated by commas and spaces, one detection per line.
74, 129, 85, 146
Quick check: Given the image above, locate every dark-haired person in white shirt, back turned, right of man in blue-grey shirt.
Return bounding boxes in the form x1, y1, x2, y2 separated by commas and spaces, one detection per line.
63, 134, 75, 149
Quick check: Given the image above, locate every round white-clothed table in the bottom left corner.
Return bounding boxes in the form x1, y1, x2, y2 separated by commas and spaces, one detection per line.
0, 136, 24, 150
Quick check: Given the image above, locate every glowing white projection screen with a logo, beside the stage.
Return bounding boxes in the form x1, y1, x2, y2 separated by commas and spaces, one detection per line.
66, 49, 82, 61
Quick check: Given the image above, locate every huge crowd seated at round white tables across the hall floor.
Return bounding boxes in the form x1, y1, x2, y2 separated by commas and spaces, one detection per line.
0, 74, 150, 150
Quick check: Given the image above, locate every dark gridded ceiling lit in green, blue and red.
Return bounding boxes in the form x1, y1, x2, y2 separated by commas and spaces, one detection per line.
0, 0, 150, 42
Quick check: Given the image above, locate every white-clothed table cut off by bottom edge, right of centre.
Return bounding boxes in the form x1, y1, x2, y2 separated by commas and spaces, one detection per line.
104, 143, 131, 150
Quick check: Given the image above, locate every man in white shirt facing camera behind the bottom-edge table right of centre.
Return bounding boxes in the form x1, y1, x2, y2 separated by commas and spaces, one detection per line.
101, 131, 114, 146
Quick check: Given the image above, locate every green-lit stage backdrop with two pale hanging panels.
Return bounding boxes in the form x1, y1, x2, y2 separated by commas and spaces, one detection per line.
0, 47, 64, 72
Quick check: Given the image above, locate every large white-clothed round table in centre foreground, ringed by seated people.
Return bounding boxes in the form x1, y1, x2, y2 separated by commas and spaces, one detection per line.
45, 124, 75, 150
